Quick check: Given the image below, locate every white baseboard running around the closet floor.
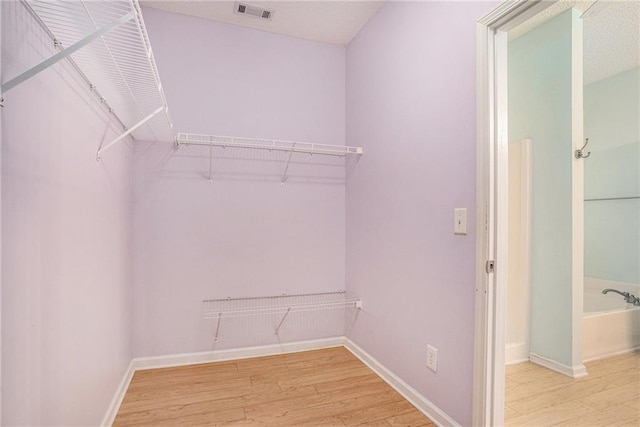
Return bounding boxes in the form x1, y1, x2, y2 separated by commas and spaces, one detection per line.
102, 337, 459, 426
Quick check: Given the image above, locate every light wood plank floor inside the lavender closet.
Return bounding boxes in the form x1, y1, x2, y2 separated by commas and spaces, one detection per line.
113, 347, 435, 426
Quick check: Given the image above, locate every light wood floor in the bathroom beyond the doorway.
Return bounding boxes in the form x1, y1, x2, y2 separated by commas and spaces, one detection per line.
505, 352, 640, 427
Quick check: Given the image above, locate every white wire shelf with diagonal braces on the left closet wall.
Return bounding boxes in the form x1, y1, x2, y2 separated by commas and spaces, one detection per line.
2, 0, 175, 158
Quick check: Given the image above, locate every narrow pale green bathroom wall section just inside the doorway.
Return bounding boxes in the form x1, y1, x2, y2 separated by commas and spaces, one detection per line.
508, 10, 582, 367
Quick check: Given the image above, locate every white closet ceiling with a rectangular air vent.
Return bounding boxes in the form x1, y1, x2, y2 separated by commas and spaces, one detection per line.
140, 0, 382, 45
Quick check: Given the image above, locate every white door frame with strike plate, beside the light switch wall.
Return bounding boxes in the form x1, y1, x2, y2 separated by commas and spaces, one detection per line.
473, 0, 557, 426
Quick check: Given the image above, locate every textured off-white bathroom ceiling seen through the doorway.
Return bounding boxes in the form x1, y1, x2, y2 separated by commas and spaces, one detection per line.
509, 0, 640, 84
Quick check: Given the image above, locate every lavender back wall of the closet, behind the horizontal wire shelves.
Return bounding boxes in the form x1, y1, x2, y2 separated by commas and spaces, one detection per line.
134, 9, 345, 356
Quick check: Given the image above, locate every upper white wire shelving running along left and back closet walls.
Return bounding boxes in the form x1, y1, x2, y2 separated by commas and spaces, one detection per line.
0, 0, 363, 176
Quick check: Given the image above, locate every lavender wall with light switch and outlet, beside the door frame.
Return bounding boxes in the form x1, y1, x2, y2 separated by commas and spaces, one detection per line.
346, 2, 497, 425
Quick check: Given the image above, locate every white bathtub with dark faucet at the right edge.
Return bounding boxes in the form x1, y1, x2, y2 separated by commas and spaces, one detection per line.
582, 277, 640, 362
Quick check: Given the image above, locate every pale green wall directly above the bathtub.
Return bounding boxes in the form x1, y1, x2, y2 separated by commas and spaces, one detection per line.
584, 68, 640, 283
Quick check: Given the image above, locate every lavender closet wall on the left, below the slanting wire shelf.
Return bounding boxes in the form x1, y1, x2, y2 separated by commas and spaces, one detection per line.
0, 2, 132, 426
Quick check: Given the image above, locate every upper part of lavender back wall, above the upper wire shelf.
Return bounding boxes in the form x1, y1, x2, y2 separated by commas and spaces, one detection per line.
143, 8, 345, 145
